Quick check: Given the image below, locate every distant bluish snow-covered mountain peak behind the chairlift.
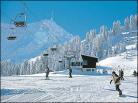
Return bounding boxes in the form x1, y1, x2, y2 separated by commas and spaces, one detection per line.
1, 20, 73, 63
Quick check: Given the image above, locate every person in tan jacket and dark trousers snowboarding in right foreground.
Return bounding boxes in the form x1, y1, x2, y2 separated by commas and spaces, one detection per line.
110, 71, 122, 96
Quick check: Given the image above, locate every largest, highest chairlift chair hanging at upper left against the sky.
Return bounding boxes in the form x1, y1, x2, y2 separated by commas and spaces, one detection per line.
14, 13, 26, 27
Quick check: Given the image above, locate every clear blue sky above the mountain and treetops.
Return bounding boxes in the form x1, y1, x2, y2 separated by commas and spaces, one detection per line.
1, 1, 137, 39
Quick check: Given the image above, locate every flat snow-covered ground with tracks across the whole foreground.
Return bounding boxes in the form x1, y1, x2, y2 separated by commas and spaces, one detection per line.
1, 72, 138, 102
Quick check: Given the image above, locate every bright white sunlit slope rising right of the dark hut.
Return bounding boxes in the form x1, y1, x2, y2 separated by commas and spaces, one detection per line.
97, 44, 137, 75
